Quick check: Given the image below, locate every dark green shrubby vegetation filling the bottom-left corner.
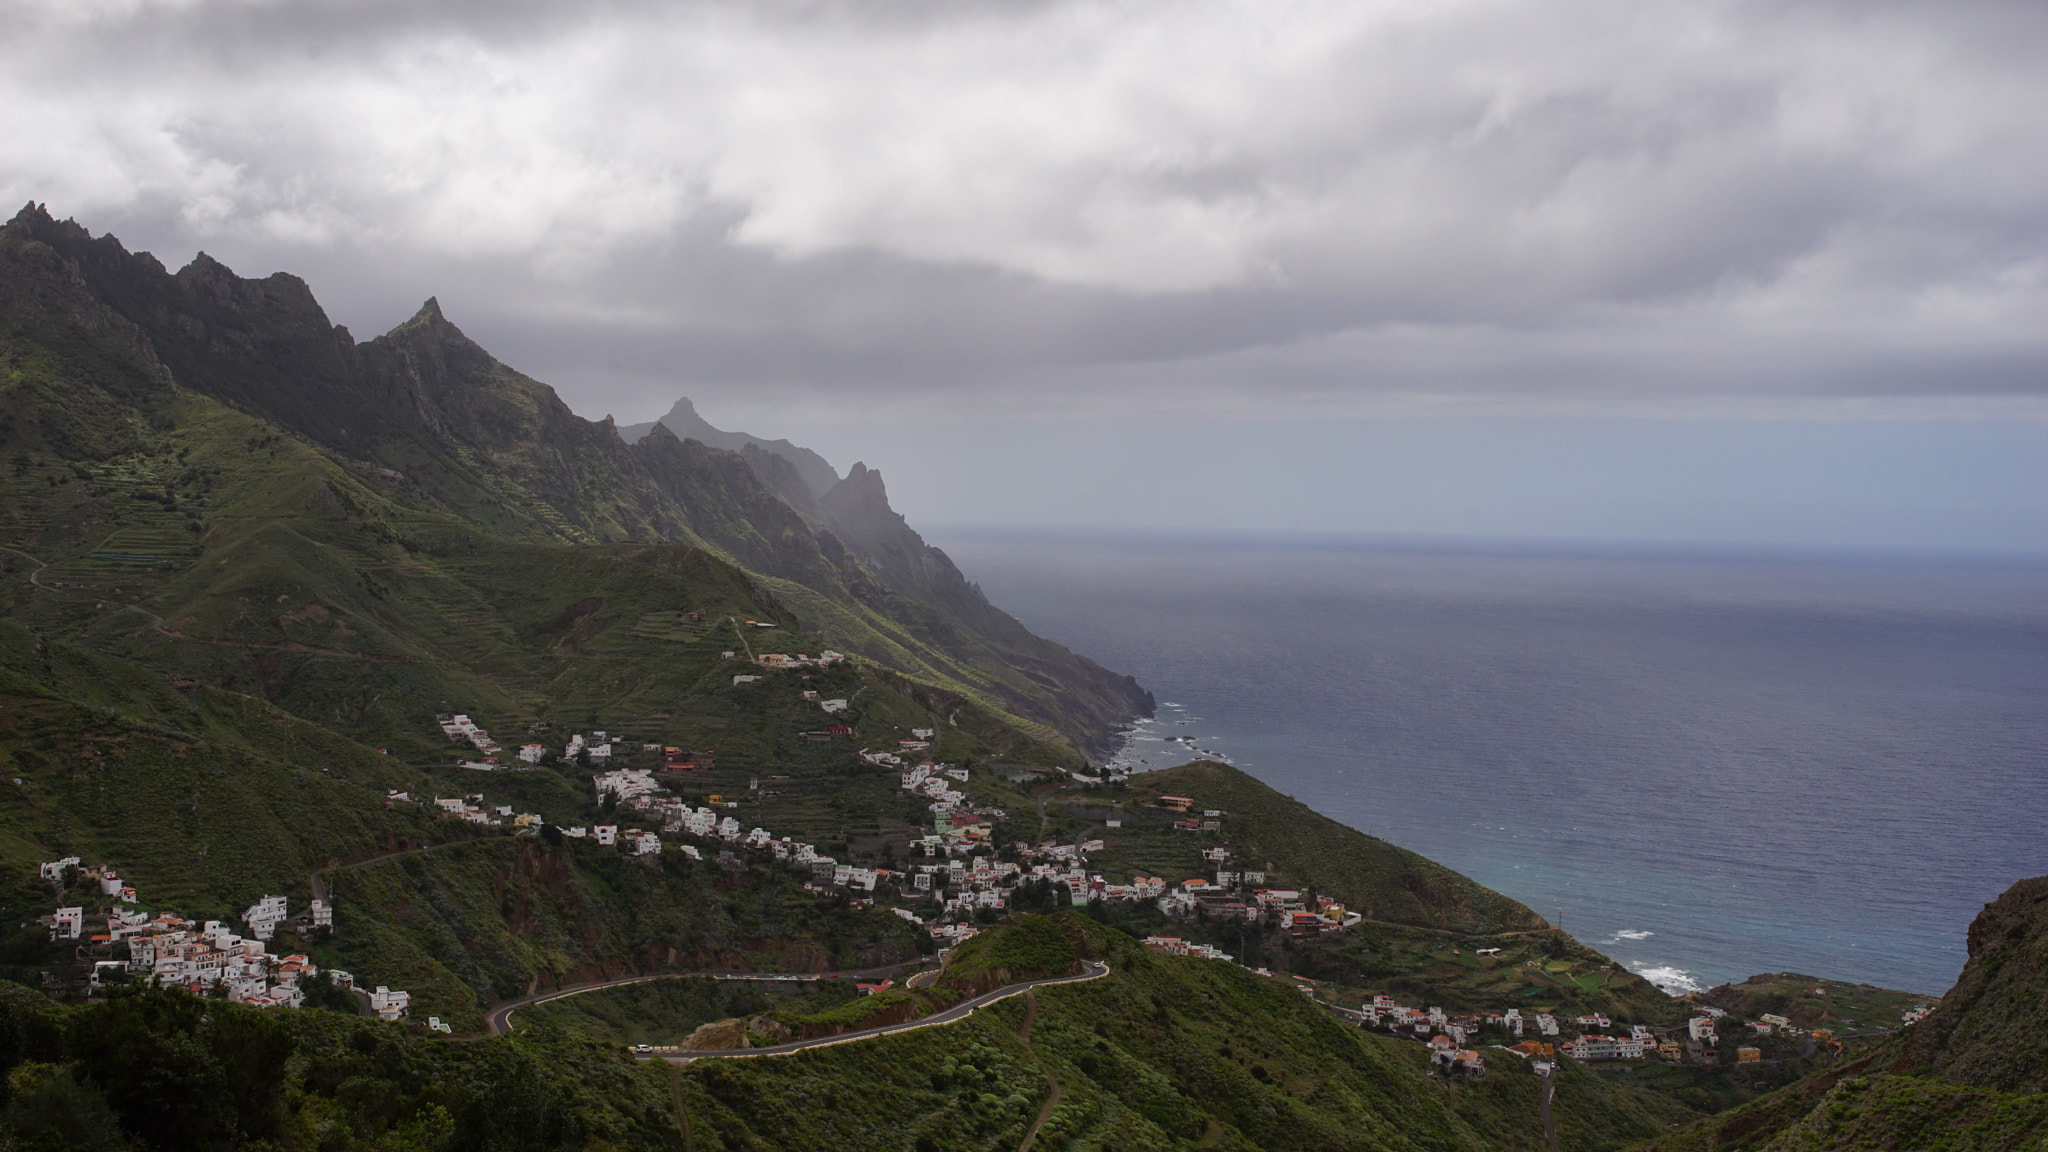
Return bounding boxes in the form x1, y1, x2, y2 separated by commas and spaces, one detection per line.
0, 986, 684, 1152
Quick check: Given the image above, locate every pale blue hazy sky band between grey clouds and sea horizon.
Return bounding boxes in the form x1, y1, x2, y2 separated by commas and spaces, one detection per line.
671, 404, 2048, 556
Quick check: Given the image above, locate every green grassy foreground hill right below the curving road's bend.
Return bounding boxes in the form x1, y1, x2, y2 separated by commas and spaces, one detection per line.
667, 914, 1692, 1152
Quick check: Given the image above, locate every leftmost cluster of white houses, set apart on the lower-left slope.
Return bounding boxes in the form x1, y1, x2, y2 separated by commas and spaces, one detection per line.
39, 857, 385, 1008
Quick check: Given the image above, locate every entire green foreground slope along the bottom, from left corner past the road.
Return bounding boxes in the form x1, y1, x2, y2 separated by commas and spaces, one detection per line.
0, 914, 1728, 1152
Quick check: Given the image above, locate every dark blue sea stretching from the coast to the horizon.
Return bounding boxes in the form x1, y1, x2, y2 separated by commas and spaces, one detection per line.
934, 529, 2048, 992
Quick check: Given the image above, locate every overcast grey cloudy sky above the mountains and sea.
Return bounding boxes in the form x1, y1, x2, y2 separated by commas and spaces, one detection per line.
0, 0, 2048, 547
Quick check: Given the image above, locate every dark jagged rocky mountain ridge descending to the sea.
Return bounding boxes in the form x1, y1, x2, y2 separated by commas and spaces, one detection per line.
4, 205, 1151, 754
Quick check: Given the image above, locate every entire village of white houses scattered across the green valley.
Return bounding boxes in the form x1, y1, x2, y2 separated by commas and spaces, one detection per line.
28, 635, 1927, 1076
